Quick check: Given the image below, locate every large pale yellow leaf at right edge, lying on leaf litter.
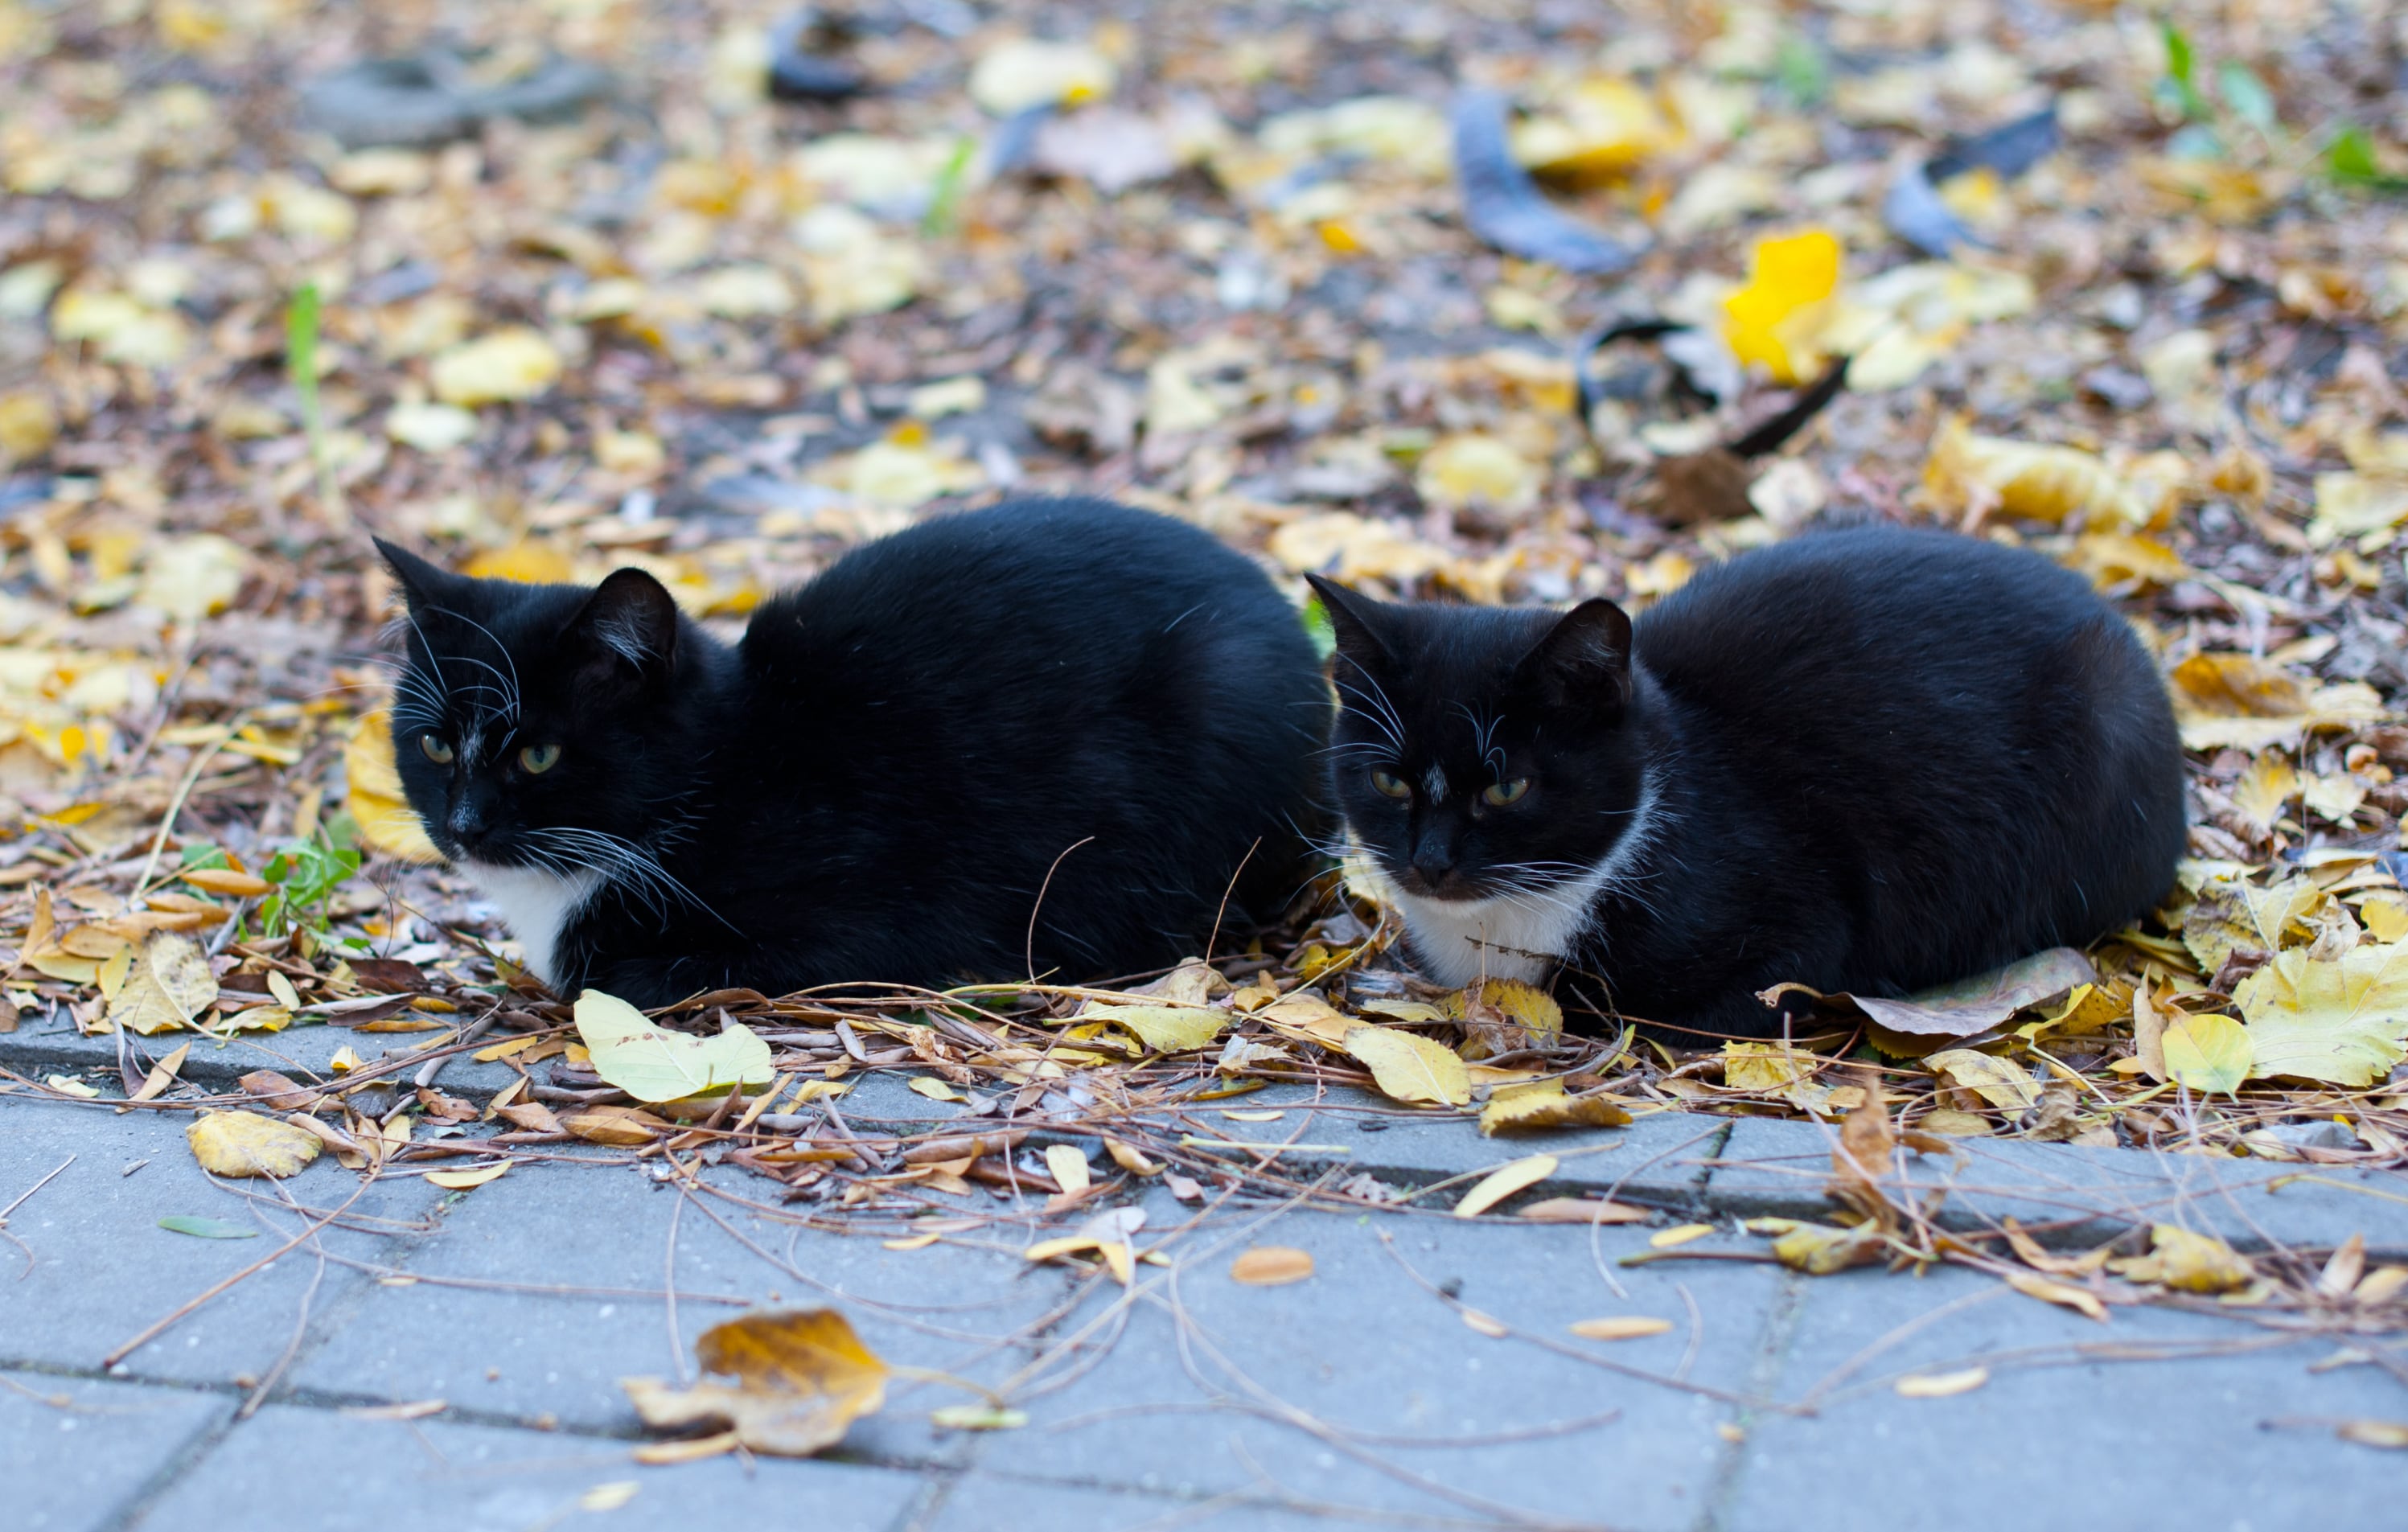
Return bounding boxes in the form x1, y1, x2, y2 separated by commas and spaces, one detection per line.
2232, 942, 2408, 1089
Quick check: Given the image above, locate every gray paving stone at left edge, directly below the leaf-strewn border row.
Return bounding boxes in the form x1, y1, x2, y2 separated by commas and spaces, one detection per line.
0, 1096, 441, 1382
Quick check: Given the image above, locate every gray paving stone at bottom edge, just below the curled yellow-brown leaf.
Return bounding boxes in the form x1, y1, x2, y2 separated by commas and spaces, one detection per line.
130, 1404, 923, 1532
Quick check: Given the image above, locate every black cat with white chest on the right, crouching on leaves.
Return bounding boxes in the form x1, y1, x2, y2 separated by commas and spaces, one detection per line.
1313, 528, 2184, 1036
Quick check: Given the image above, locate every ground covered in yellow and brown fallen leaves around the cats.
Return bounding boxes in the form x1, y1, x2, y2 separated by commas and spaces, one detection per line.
0, 0, 2408, 1443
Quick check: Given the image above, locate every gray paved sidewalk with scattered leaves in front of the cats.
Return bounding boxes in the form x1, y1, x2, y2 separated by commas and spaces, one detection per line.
0, 1078, 2408, 1532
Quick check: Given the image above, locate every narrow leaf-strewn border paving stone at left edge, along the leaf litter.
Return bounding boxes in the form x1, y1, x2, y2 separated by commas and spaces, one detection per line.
0, 1019, 518, 1101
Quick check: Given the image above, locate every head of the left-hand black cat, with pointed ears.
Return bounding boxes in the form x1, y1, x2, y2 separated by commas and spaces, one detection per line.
378, 542, 679, 877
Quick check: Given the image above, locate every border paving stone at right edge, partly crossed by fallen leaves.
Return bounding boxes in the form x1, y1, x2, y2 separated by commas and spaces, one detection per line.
1705, 1118, 2408, 1258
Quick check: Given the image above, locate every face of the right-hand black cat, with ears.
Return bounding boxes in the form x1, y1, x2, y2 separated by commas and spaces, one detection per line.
1313, 578, 1642, 903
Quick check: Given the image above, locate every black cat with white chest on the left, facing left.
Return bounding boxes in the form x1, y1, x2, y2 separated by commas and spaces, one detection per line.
378, 501, 1329, 1004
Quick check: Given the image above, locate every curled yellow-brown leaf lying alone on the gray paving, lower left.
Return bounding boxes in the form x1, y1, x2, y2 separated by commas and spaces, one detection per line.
618, 1308, 886, 1457
